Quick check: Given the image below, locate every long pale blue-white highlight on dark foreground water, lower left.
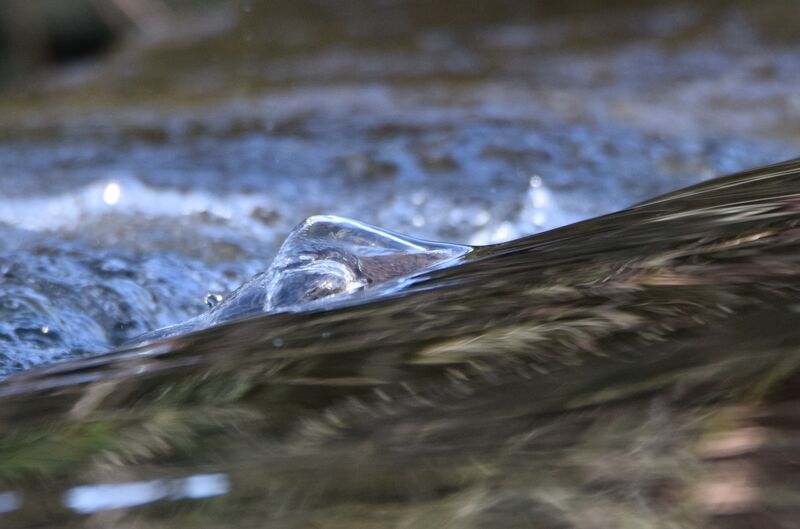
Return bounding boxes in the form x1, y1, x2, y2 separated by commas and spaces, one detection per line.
64, 474, 230, 514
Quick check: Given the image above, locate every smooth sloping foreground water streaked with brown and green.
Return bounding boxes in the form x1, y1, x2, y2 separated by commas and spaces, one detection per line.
0, 161, 800, 528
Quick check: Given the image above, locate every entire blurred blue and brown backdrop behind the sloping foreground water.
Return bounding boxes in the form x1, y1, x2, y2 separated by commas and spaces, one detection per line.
0, 0, 800, 373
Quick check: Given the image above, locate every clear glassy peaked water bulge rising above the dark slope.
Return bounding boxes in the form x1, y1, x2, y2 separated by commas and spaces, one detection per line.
132, 215, 471, 343
